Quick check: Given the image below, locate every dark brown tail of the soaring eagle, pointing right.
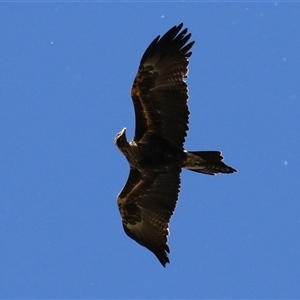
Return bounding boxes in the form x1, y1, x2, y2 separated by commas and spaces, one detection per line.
184, 151, 236, 175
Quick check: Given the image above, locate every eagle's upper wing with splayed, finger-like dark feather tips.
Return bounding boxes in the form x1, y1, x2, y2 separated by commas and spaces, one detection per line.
131, 24, 194, 148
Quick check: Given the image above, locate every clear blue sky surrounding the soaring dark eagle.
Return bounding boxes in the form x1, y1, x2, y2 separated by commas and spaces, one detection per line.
0, 2, 300, 298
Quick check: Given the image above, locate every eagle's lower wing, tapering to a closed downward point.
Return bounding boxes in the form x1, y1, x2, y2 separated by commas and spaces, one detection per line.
118, 168, 181, 266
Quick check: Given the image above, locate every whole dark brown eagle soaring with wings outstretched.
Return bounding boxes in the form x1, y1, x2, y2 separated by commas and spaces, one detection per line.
115, 23, 236, 267
